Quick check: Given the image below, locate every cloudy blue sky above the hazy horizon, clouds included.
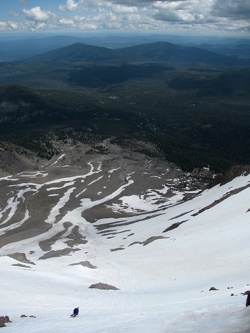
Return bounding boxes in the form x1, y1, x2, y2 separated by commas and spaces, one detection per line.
0, 0, 250, 36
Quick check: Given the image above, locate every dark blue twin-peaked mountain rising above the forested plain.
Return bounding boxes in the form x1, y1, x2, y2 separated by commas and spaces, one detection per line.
28, 42, 250, 66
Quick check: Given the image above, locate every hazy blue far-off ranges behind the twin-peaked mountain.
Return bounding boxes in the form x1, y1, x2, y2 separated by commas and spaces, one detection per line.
0, 34, 250, 61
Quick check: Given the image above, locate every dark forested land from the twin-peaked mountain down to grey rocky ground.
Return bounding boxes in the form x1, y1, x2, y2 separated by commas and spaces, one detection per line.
0, 42, 250, 172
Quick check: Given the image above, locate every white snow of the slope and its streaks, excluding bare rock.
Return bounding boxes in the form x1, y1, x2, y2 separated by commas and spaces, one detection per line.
0, 170, 250, 333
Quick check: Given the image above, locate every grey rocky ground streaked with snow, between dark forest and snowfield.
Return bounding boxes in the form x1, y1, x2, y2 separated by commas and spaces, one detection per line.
0, 140, 211, 262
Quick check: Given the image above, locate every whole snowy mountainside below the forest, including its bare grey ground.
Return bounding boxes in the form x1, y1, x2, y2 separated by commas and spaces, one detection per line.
0, 141, 250, 333
